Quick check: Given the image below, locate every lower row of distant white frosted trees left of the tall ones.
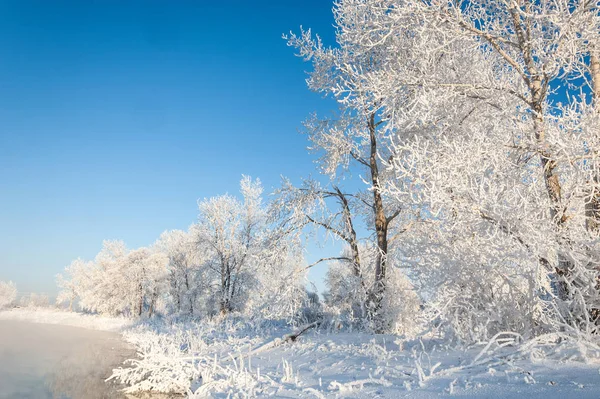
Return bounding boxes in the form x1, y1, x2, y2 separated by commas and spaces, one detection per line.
57, 177, 314, 318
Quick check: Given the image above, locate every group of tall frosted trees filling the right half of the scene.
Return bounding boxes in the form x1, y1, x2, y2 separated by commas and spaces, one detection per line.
285, 0, 600, 340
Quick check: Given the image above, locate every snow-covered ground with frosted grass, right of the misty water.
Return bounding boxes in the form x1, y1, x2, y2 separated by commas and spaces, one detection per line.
108, 324, 600, 399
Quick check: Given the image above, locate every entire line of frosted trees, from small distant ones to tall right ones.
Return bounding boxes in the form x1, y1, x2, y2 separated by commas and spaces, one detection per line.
61, 0, 600, 341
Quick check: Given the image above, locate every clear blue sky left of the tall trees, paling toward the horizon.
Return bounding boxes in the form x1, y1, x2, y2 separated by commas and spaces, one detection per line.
0, 0, 334, 294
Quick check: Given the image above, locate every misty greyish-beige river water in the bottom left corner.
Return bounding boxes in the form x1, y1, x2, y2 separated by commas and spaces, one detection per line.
0, 320, 134, 399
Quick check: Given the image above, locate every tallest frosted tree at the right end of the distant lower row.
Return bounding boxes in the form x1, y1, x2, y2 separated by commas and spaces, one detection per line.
194, 176, 310, 314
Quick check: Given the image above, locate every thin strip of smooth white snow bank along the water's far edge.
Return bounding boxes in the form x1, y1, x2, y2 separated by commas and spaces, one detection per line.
0, 308, 134, 332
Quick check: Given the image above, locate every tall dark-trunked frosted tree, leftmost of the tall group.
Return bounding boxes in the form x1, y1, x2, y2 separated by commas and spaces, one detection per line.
285, 8, 414, 329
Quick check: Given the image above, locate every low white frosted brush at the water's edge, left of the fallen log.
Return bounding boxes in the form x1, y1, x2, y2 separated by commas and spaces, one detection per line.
110, 315, 287, 397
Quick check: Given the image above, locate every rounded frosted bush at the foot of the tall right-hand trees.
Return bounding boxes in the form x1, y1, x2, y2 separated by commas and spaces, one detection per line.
405, 227, 550, 342
